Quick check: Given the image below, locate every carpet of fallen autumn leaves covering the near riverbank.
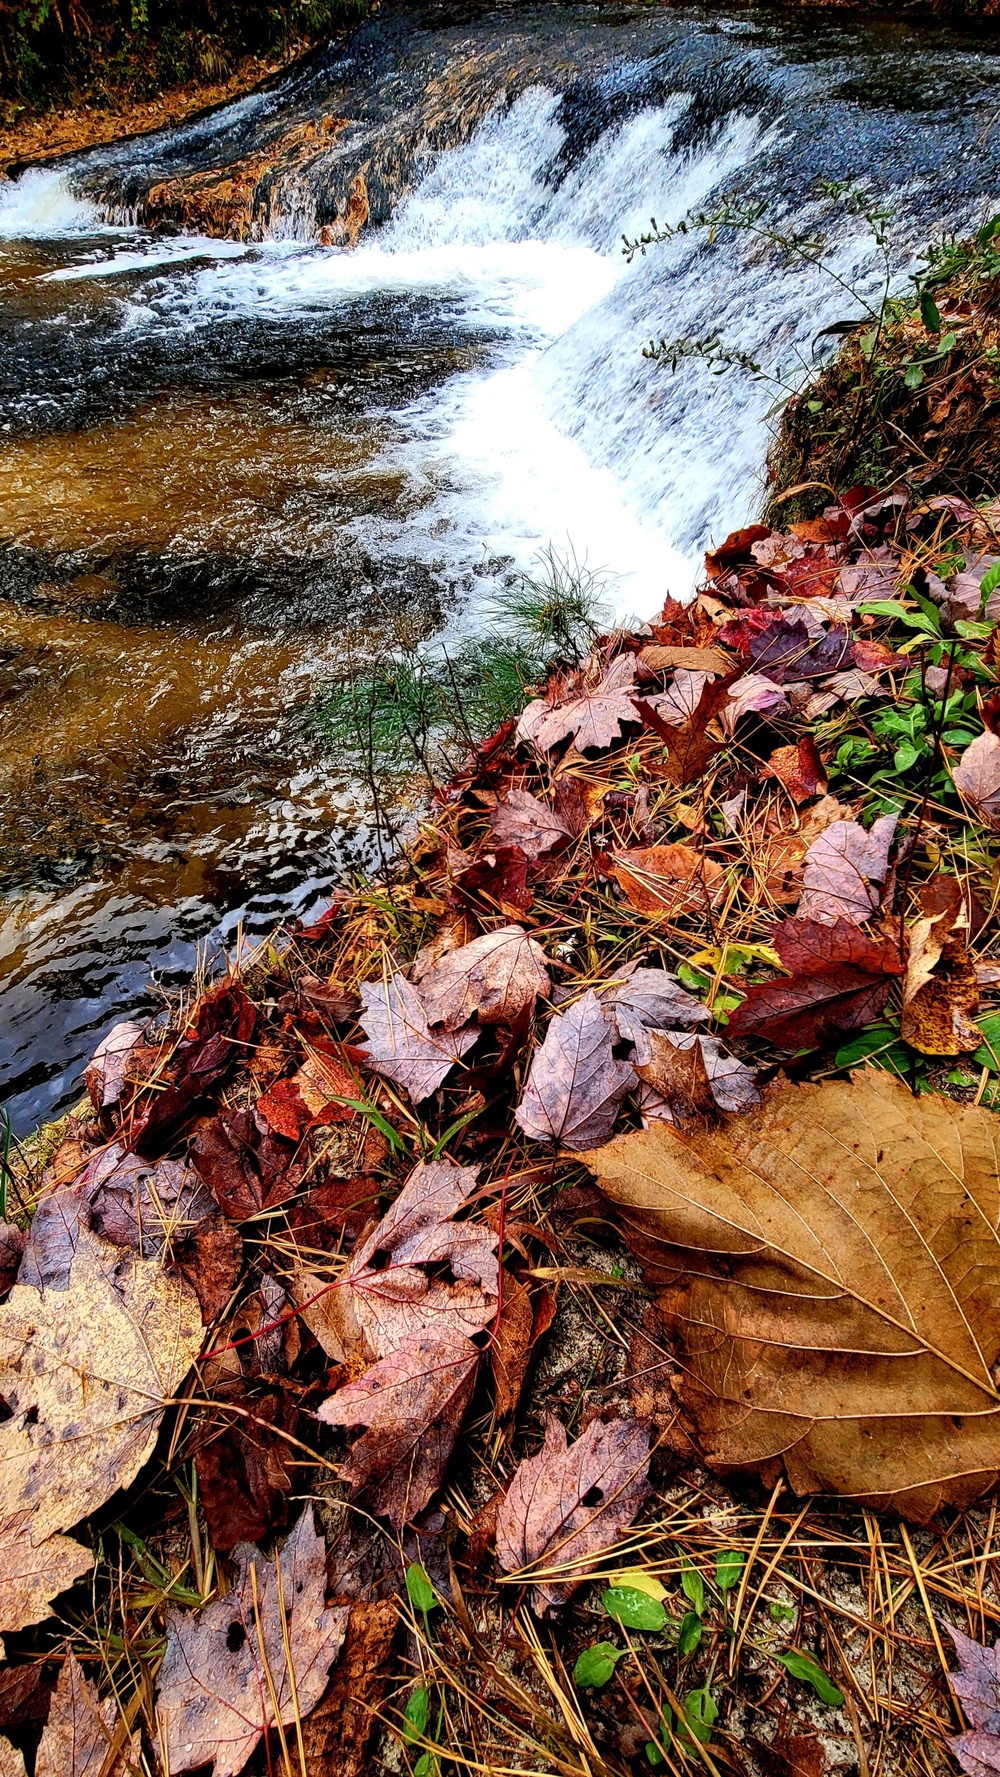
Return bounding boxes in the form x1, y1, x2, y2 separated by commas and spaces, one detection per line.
9, 472, 1000, 1777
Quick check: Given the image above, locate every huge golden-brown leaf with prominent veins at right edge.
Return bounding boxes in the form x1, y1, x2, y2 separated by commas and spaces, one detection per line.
584, 1070, 1000, 1519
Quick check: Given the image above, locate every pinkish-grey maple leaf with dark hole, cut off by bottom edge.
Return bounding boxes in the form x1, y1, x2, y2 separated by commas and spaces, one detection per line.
156, 1505, 348, 1777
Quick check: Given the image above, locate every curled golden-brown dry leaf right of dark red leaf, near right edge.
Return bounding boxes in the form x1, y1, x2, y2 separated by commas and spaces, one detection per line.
901, 874, 982, 1056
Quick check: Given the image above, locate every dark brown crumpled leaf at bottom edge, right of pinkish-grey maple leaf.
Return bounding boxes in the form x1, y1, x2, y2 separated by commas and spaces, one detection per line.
302, 1598, 400, 1777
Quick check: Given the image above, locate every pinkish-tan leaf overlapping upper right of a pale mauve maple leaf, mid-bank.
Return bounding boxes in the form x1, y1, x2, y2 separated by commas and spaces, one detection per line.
421, 926, 551, 1031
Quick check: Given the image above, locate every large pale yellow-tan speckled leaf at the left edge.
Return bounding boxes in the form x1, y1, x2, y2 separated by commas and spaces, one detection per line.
0, 1228, 202, 1548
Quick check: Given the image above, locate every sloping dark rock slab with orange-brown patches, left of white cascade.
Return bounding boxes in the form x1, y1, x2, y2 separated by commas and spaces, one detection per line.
66, 5, 618, 245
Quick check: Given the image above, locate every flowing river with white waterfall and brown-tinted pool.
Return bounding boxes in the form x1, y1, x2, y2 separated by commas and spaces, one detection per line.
0, 4, 1000, 1128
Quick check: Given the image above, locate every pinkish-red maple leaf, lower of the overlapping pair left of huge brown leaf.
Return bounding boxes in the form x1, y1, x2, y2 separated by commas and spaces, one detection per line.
316, 1326, 480, 1530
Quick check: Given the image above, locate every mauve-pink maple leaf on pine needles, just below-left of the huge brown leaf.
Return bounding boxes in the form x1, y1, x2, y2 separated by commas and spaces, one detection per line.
497, 1413, 650, 1614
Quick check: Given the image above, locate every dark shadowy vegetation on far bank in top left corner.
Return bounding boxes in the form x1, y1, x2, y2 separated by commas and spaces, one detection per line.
0, 0, 369, 108
